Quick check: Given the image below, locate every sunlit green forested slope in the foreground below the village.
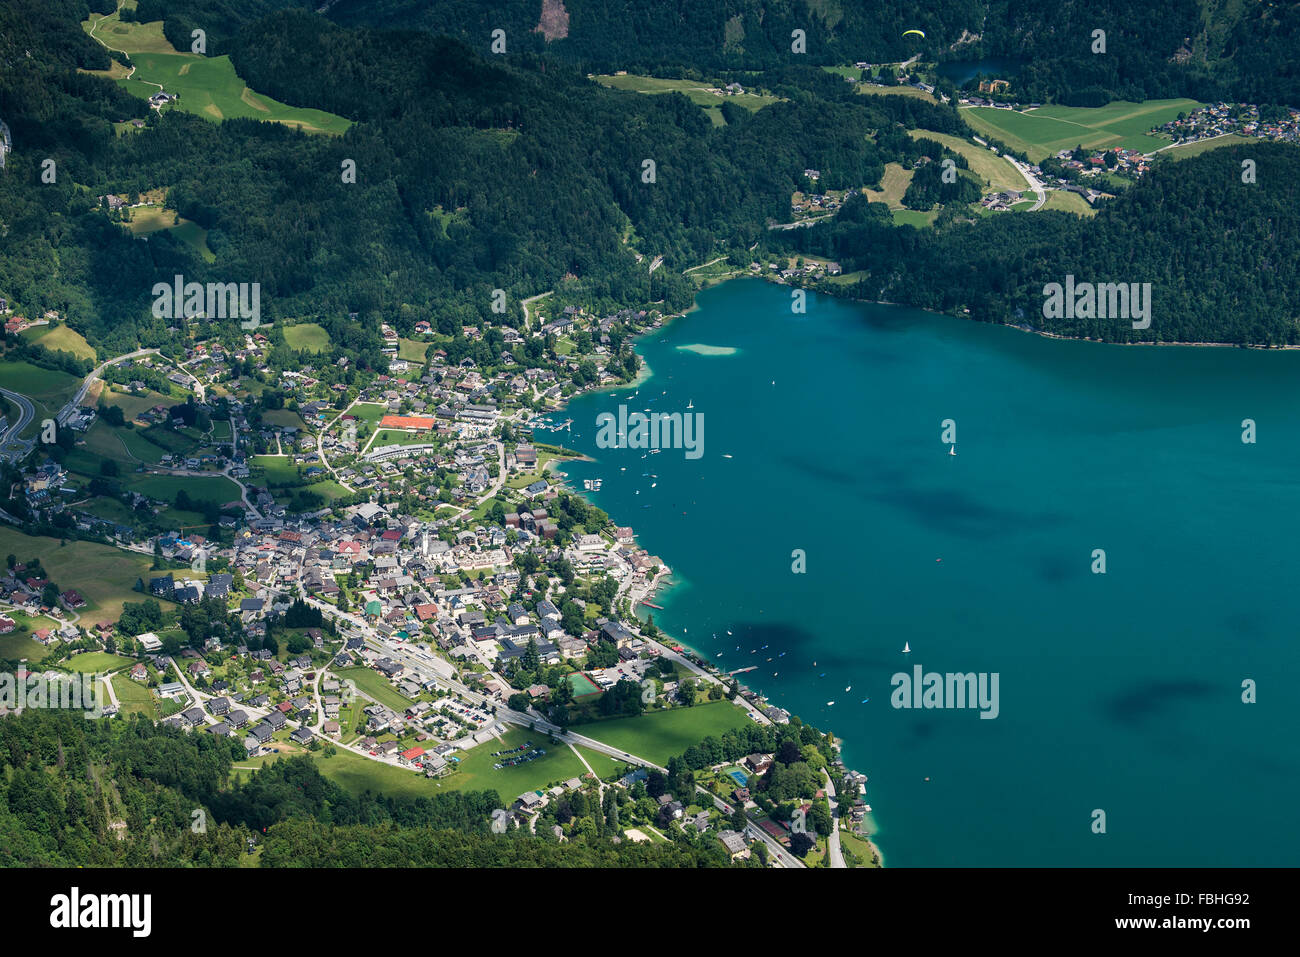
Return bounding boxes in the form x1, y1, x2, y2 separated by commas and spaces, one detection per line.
0, 710, 729, 867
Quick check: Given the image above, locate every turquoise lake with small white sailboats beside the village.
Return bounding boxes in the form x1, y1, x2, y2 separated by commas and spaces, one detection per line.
556, 280, 1300, 866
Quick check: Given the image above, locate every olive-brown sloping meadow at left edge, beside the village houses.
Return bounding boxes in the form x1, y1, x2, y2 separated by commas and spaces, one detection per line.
0, 527, 151, 624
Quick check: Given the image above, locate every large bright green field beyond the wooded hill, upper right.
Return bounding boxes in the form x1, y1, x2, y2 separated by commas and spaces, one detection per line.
961, 99, 1203, 163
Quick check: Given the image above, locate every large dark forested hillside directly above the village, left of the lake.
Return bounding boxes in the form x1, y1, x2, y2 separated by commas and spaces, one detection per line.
0, 0, 959, 355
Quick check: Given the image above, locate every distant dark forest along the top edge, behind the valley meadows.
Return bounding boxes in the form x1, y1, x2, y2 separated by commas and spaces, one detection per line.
317, 0, 1300, 105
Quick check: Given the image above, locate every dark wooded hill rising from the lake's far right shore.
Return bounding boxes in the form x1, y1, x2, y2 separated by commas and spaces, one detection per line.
785, 144, 1300, 345
